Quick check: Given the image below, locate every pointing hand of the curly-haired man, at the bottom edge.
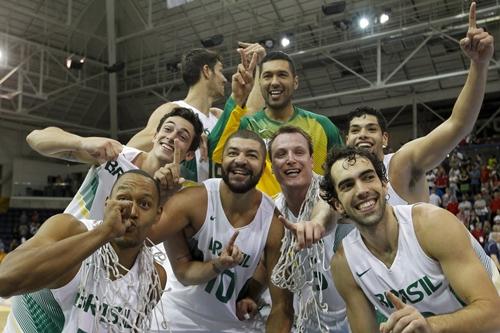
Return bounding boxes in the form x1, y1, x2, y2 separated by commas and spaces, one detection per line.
380, 292, 432, 333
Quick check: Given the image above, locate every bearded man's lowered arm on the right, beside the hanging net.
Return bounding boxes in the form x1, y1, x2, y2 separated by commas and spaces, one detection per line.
263, 212, 293, 333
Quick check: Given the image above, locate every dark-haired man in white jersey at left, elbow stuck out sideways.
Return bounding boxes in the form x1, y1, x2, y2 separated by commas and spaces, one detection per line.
26, 107, 203, 219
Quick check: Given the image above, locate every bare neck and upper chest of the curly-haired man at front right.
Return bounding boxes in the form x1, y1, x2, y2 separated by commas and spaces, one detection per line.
357, 205, 399, 267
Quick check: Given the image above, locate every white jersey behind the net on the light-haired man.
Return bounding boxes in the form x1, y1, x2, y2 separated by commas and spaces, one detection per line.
275, 193, 354, 333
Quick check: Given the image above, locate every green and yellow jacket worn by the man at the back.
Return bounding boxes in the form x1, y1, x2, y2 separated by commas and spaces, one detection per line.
210, 98, 342, 196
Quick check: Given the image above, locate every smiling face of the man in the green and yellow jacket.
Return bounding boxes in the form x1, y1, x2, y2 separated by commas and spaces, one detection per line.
260, 60, 298, 110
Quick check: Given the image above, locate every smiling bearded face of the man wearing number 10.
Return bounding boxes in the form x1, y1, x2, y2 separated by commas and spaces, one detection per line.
222, 137, 265, 193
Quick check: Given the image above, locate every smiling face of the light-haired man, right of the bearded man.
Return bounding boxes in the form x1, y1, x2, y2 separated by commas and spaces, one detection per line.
270, 133, 313, 188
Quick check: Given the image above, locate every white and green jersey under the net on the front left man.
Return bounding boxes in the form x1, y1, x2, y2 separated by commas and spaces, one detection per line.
4, 220, 143, 333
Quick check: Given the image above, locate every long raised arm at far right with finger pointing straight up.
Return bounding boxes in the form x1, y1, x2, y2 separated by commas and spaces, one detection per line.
394, 2, 494, 175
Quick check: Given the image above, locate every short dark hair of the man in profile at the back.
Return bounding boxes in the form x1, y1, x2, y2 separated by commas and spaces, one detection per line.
181, 48, 222, 88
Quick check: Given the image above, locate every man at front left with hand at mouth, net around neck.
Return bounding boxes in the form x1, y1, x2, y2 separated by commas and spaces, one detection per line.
0, 170, 167, 333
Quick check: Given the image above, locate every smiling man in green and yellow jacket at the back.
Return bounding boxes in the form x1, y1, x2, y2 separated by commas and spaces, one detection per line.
209, 52, 342, 196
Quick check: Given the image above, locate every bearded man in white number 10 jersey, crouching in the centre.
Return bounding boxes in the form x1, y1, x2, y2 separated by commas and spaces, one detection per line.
153, 130, 293, 332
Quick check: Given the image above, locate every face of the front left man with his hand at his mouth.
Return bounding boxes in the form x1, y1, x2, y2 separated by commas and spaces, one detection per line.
110, 173, 161, 248
